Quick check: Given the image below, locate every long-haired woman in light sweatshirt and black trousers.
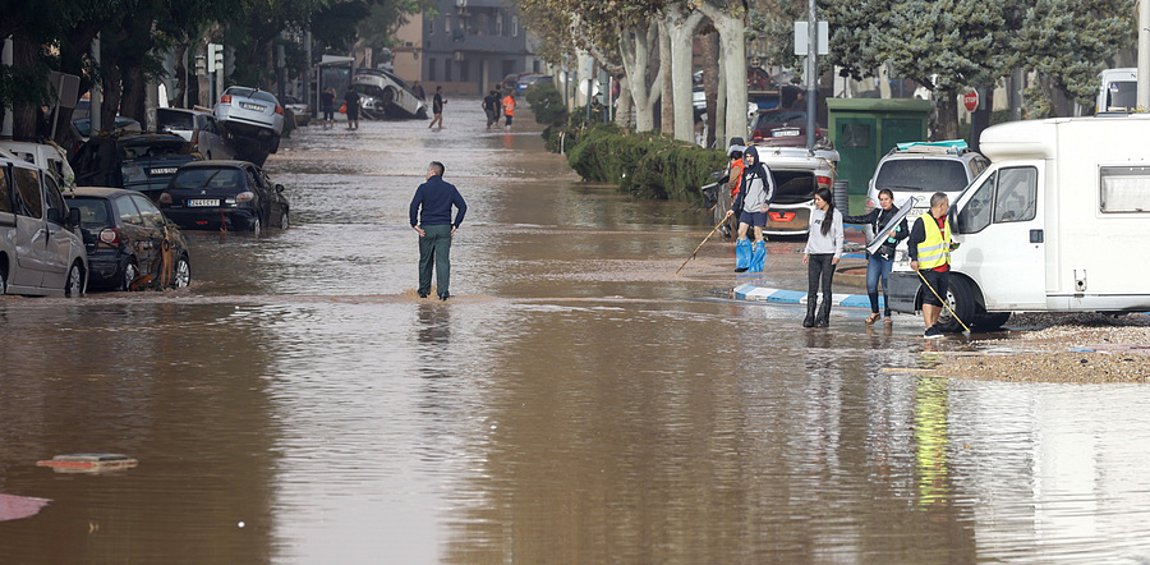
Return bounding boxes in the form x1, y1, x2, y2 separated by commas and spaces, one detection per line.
803, 189, 843, 328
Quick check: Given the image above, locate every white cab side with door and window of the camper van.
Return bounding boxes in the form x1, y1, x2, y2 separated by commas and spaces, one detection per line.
951, 161, 1047, 312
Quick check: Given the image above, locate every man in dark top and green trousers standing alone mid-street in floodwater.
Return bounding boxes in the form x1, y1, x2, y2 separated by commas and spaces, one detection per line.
409, 161, 467, 300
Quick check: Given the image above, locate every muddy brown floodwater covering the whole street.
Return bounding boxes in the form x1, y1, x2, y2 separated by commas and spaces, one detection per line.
0, 100, 1150, 564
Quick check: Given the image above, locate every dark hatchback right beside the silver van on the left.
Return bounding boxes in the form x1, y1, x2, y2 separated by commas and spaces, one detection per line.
64, 186, 192, 290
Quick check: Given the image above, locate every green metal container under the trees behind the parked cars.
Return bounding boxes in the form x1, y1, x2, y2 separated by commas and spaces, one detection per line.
827, 98, 933, 214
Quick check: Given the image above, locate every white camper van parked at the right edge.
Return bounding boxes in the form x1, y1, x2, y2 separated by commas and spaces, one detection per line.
890, 114, 1150, 330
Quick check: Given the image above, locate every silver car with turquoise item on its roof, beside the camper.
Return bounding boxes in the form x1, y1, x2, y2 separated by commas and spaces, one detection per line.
866, 139, 990, 222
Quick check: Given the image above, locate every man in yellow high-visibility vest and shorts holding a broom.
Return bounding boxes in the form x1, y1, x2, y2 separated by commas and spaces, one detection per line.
906, 192, 958, 339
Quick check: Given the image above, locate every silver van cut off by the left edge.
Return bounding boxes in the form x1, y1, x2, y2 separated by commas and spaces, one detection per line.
0, 156, 87, 297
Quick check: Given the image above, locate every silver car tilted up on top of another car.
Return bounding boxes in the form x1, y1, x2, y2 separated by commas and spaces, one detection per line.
215, 86, 284, 165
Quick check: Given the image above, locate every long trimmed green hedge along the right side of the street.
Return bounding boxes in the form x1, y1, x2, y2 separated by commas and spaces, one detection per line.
561, 124, 727, 205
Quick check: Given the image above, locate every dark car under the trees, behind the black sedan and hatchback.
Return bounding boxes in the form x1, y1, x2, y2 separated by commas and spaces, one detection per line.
71, 133, 196, 193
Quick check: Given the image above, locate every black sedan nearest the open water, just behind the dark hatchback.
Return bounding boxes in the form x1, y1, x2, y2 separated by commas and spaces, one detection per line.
159, 161, 290, 236
